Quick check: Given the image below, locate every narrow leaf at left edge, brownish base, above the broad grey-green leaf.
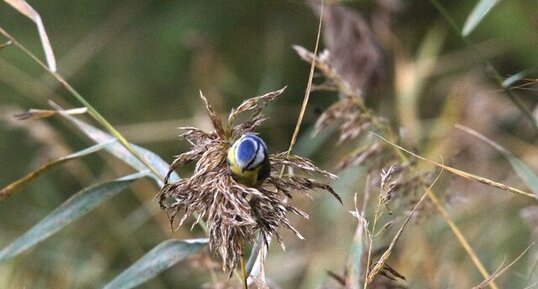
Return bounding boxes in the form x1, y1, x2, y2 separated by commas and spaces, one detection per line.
0, 140, 115, 201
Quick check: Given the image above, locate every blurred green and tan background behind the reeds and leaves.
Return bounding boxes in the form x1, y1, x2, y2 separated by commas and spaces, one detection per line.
0, 0, 538, 289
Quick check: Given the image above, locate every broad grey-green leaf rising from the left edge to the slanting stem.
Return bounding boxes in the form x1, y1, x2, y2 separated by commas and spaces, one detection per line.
0, 171, 149, 263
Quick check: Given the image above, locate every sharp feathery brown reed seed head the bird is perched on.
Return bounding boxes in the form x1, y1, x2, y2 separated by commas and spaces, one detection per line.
158, 88, 341, 271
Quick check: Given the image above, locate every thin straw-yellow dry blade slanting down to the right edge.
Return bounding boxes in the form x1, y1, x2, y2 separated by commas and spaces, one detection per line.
372, 132, 538, 200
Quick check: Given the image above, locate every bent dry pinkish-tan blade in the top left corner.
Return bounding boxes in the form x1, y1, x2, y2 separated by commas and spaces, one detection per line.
4, 0, 56, 72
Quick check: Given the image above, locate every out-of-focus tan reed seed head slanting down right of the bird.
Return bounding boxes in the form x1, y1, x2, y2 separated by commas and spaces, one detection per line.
294, 40, 432, 220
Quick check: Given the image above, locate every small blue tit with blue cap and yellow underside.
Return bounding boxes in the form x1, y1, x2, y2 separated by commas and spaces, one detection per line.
227, 133, 271, 187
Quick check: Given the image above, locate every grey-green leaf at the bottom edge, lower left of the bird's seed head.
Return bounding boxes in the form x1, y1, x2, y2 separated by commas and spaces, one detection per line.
103, 239, 208, 289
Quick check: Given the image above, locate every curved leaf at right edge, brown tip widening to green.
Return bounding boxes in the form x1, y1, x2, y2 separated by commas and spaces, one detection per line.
456, 125, 538, 198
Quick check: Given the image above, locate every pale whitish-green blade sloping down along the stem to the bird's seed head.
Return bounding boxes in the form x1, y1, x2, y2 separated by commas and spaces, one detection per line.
62, 114, 179, 186
